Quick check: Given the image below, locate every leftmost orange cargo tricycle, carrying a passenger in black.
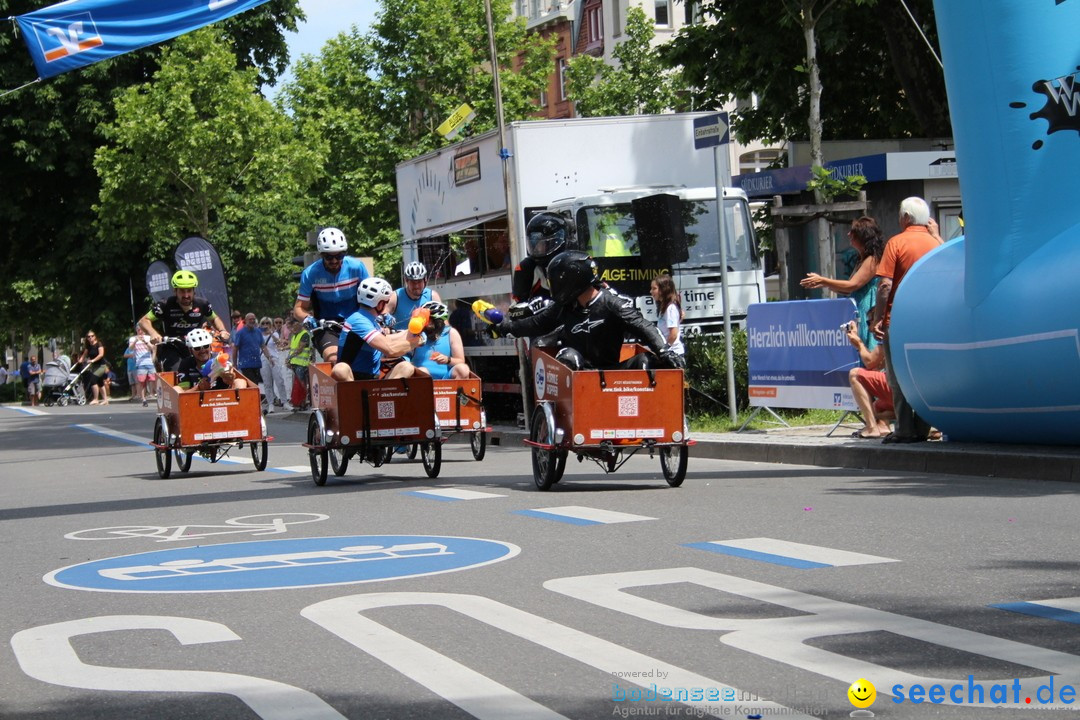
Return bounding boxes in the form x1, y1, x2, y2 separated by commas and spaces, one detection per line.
150, 372, 273, 478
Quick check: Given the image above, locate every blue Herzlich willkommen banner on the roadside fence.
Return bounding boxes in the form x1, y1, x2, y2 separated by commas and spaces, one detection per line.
746, 298, 860, 410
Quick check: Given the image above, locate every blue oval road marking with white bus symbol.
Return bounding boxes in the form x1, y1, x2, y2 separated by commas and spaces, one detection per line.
44, 535, 521, 593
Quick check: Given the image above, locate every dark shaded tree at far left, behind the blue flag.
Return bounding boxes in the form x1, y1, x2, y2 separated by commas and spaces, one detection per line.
0, 0, 302, 350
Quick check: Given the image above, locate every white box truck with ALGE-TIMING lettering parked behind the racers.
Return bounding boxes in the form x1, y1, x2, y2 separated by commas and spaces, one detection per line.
396, 113, 766, 403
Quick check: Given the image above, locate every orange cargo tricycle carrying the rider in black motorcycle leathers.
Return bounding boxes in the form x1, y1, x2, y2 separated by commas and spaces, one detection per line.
525, 343, 693, 490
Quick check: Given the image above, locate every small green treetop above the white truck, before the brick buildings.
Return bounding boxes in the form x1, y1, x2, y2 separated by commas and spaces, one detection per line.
567, 8, 688, 118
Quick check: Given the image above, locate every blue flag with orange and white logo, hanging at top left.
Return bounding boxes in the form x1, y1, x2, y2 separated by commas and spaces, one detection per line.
15, 0, 267, 79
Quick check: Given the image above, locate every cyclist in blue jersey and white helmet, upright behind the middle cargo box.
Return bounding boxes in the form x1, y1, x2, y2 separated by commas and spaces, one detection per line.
293, 228, 368, 364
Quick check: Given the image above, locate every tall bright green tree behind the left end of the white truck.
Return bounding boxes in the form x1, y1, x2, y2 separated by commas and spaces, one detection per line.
281, 0, 553, 277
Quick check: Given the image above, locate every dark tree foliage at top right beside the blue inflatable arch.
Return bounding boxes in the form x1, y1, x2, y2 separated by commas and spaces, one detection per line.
661, 0, 950, 142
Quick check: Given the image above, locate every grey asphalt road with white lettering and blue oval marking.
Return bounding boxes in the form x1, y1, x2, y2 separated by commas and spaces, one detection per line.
0, 404, 1080, 720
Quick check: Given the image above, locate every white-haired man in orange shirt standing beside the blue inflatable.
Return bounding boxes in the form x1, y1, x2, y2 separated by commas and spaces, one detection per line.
874, 198, 941, 445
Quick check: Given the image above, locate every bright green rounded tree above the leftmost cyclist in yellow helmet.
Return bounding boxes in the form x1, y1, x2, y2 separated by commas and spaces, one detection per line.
92, 27, 324, 310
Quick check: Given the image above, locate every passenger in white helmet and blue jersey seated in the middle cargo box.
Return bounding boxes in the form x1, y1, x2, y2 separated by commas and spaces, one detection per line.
330, 277, 423, 381
